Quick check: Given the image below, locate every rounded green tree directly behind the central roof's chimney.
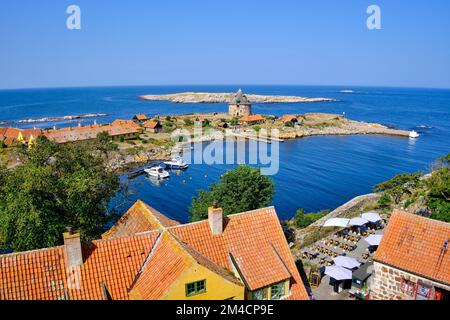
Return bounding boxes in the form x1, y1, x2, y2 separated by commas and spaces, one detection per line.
189, 165, 274, 221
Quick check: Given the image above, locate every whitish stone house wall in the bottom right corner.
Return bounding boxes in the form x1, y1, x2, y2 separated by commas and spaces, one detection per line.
370, 261, 450, 300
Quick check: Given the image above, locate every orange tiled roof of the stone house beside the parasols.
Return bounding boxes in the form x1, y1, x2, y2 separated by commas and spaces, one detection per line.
374, 210, 450, 284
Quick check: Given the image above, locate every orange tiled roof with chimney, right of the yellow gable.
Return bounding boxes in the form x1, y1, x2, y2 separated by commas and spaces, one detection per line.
168, 207, 308, 299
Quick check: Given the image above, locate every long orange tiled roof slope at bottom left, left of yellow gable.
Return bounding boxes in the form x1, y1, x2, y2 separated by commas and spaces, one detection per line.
0, 233, 158, 300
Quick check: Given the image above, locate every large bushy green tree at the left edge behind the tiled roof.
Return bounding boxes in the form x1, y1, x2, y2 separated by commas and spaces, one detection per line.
0, 137, 119, 251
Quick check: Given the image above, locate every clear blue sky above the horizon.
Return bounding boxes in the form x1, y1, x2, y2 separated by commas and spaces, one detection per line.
0, 0, 450, 89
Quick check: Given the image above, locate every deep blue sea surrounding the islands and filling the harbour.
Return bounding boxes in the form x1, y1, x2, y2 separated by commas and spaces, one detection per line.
0, 86, 450, 221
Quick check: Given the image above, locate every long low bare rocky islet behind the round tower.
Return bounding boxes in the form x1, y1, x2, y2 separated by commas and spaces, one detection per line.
139, 92, 336, 103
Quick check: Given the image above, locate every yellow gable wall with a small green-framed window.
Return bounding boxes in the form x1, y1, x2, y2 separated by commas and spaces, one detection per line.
163, 264, 245, 300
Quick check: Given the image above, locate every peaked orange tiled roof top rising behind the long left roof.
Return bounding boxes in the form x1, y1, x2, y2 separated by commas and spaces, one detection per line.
102, 200, 179, 239
